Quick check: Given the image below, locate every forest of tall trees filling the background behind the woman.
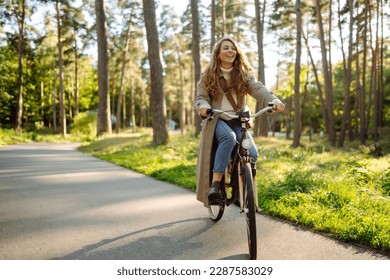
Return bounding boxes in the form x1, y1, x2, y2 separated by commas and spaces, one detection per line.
0, 0, 390, 147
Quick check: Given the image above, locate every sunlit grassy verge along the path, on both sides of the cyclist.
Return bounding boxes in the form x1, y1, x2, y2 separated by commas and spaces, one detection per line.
80, 130, 390, 252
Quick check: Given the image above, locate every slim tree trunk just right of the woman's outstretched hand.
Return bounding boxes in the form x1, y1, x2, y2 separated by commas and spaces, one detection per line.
292, 0, 302, 148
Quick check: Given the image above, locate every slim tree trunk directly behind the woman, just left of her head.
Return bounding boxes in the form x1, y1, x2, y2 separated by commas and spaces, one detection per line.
191, 0, 201, 135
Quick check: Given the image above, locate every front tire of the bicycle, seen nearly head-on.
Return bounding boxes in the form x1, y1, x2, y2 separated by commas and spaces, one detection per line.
244, 163, 257, 260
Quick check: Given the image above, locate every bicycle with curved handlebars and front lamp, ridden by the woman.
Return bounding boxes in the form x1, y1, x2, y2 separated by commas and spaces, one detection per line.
205, 103, 276, 260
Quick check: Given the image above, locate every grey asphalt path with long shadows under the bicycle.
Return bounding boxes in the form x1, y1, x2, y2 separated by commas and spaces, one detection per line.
0, 143, 389, 260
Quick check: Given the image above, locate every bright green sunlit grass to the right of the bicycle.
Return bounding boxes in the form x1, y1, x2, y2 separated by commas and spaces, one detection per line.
258, 140, 390, 251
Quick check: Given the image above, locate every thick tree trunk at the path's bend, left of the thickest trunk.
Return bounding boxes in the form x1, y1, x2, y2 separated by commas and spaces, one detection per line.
95, 0, 111, 136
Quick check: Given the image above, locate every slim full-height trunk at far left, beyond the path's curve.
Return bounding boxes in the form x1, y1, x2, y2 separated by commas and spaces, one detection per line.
56, 0, 66, 137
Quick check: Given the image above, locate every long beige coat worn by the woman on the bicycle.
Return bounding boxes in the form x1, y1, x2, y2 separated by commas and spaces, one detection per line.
194, 73, 277, 207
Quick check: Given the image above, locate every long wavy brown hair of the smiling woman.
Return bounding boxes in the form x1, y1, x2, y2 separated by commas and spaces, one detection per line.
200, 37, 253, 97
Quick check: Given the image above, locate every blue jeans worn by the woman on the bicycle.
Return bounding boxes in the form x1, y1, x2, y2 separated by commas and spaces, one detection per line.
213, 119, 259, 173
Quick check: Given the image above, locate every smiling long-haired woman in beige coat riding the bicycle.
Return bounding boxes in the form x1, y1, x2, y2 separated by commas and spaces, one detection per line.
194, 37, 285, 207
